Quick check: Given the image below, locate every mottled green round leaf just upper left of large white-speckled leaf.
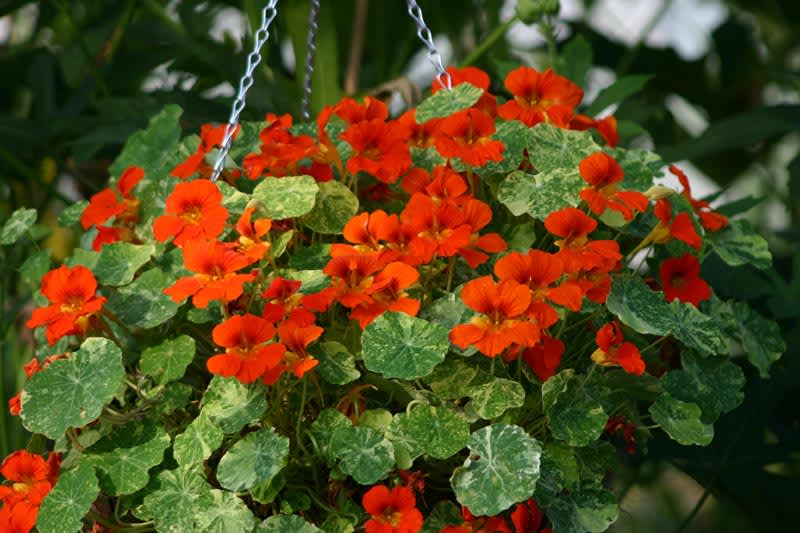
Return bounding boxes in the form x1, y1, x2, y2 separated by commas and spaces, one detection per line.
403, 405, 469, 459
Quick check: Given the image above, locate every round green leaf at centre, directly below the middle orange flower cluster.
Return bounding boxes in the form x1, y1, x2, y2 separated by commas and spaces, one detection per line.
361, 313, 450, 379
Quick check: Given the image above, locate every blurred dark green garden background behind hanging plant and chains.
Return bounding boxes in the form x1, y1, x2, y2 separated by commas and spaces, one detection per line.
0, 0, 800, 532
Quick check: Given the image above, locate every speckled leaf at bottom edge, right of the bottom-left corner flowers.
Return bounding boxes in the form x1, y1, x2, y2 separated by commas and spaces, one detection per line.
36, 463, 100, 533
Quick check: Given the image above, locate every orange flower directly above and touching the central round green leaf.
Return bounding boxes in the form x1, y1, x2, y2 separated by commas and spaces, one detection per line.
350, 261, 420, 329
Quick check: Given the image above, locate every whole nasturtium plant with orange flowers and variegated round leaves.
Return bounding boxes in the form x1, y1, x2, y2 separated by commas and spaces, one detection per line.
0, 58, 786, 533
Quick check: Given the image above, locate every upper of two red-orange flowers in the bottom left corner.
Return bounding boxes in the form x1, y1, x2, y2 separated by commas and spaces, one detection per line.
0, 450, 61, 511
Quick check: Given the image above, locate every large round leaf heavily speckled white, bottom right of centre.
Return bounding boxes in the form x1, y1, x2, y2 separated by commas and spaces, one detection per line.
450, 424, 542, 516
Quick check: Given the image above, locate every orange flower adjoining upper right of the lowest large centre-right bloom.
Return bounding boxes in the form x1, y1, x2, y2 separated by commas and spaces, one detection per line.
494, 250, 583, 329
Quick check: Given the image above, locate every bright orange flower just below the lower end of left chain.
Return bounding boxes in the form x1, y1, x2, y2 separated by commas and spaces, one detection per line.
153, 180, 228, 247
